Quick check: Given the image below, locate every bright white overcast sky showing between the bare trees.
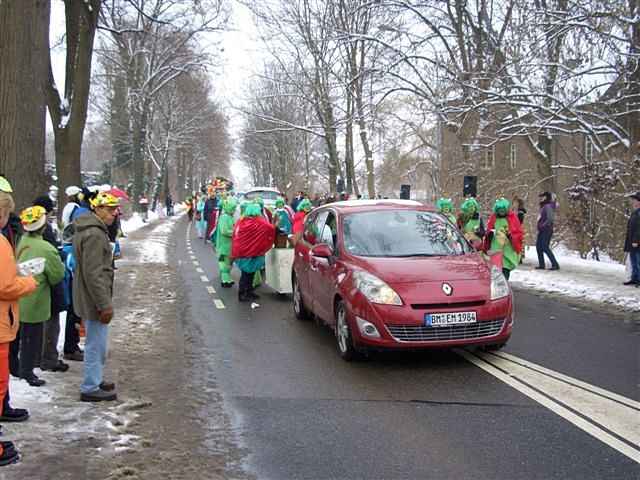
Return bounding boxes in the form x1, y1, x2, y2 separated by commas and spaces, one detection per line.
47, 0, 264, 188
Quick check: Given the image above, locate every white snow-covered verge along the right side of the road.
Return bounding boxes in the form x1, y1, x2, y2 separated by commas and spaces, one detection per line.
511, 246, 640, 311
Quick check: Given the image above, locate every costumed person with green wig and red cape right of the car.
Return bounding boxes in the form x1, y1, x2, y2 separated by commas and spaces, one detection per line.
483, 198, 524, 280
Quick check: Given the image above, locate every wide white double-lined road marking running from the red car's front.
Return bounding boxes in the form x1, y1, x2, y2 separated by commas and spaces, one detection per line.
456, 350, 640, 463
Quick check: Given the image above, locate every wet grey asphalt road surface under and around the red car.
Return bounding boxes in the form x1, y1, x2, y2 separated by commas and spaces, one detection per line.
175, 220, 640, 479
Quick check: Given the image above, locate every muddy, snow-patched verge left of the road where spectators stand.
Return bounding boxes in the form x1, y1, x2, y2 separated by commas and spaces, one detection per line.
0, 217, 232, 480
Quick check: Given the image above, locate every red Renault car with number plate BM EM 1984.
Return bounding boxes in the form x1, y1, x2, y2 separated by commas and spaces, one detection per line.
292, 200, 513, 360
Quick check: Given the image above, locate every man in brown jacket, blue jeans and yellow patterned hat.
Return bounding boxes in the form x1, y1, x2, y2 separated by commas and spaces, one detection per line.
73, 193, 119, 402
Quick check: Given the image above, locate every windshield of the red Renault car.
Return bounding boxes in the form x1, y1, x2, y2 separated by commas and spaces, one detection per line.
343, 210, 472, 257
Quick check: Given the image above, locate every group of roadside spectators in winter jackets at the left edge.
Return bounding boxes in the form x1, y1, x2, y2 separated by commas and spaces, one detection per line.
0, 176, 122, 466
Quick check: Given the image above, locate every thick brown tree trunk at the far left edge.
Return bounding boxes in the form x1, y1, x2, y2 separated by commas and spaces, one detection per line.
0, 0, 50, 209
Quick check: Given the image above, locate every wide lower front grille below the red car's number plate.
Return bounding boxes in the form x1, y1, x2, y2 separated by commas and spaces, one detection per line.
387, 320, 504, 342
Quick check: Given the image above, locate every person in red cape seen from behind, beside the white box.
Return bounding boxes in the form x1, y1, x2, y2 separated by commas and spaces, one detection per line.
231, 203, 276, 302
